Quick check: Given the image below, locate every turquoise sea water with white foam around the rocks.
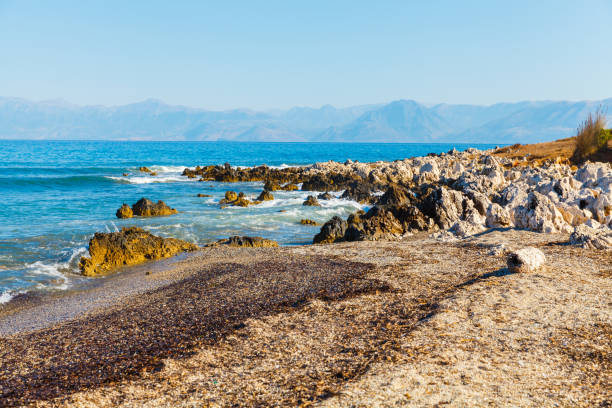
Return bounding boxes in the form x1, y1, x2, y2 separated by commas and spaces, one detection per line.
0, 140, 493, 303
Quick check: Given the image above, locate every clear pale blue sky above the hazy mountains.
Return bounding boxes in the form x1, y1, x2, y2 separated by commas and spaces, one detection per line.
0, 0, 612, 109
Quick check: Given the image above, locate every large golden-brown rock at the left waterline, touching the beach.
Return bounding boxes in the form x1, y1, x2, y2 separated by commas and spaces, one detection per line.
79, 227, 198, 276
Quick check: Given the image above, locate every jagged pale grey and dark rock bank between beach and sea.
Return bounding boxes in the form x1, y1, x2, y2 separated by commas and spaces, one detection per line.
183, 148, 612, 249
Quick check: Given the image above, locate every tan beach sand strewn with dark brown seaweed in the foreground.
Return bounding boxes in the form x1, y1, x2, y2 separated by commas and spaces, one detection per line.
0, 230, 612, 407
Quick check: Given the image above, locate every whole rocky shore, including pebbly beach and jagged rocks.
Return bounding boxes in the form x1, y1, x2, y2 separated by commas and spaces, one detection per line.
0, 143, 612, 407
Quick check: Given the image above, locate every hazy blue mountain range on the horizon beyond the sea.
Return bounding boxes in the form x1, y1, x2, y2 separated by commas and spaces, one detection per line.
0, 98, 612, 143
